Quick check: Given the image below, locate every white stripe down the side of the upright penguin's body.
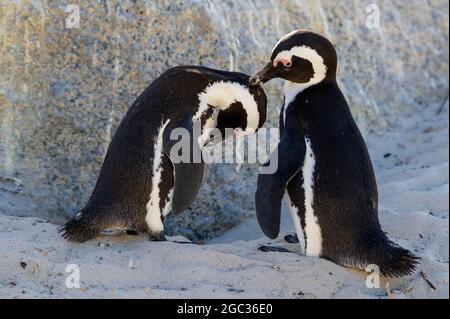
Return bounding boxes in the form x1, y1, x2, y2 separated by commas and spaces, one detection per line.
302, 137, 322, 257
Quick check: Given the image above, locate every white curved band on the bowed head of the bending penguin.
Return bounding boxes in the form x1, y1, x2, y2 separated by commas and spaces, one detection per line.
193, 81, 259, 134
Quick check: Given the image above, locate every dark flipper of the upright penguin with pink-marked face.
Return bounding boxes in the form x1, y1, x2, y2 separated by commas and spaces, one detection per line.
255, 131, 306, 239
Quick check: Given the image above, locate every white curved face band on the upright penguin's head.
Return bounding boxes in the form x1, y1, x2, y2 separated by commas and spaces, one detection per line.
274, 46, 327, 92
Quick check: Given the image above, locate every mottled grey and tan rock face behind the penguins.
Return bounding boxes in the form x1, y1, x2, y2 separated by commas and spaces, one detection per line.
0, 0, 449, 240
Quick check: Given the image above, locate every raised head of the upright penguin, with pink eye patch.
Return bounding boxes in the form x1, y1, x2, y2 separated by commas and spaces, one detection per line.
250, 30, 337, 88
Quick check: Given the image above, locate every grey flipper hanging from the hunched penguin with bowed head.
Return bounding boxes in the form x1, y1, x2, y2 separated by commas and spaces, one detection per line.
163, 115, 204, 214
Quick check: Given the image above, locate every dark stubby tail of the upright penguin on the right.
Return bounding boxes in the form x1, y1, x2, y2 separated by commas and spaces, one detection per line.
364, 237, 420, 277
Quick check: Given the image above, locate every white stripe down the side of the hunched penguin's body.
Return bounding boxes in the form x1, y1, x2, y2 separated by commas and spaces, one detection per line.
145, 120, 170, 233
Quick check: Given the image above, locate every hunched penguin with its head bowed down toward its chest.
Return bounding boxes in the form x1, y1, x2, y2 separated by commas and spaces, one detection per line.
60, 66, 267, 242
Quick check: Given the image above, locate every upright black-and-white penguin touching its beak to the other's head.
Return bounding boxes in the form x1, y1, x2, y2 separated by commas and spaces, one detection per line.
250, 30, 419, 276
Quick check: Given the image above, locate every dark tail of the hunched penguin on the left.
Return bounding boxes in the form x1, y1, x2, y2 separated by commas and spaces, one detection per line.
58, 213, 103, 243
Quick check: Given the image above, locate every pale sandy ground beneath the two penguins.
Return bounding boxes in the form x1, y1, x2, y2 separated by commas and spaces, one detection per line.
0, 103, 449, 298
